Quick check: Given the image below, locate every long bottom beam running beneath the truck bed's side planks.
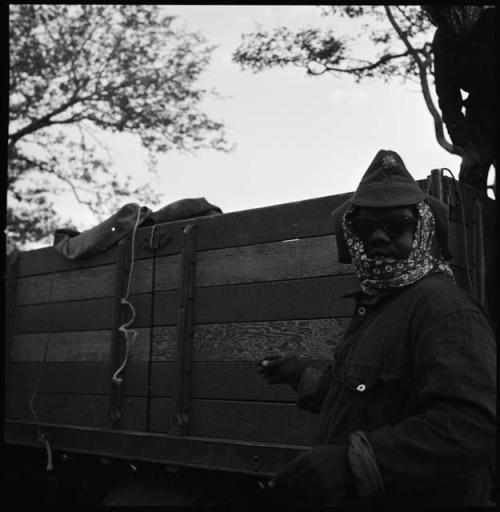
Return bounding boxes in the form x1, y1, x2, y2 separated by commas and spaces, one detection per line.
5, 421, 308, 476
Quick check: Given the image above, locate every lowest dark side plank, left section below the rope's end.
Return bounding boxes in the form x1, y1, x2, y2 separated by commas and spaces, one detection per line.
5, 392, 146, 431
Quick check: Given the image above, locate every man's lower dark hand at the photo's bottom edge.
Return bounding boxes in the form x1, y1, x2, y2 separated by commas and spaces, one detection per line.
269, 445, 356, 506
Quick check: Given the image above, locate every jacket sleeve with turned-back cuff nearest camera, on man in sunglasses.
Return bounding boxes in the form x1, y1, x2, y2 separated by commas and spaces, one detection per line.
349, 310, 496, 496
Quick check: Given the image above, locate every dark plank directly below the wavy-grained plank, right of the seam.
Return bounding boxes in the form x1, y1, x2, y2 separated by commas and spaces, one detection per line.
151, 361, 329, 403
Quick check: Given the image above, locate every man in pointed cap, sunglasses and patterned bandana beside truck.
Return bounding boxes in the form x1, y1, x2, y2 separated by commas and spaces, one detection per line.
259, 150, 496, 510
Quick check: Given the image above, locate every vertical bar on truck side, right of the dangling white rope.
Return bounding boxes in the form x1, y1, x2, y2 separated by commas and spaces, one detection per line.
170, 224, 196, 435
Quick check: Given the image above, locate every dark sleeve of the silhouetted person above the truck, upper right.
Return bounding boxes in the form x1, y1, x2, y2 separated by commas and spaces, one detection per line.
433, 32, 471, 148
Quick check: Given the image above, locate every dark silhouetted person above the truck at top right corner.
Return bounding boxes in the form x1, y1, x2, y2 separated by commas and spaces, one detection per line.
423, 5, 498, 193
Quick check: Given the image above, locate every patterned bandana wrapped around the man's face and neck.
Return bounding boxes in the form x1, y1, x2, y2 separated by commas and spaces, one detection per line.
342, 201, 454, 295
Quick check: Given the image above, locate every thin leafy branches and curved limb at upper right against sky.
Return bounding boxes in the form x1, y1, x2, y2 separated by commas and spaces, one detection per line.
233, 5, 459, 154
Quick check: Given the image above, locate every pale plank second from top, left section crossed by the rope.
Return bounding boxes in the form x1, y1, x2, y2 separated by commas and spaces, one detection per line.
17, 259, 153, 305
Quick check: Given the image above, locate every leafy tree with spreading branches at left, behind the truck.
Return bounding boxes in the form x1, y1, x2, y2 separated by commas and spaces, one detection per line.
7, 4, 230, 250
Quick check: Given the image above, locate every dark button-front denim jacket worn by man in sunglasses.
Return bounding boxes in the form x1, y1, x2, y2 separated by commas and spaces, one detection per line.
297, 274, 496, 507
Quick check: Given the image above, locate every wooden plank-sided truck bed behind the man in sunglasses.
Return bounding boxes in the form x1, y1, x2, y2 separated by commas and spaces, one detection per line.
5, 176, 496, 474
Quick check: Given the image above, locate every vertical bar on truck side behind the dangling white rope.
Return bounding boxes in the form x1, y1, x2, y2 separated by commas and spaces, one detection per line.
108, 238, 129, 427
